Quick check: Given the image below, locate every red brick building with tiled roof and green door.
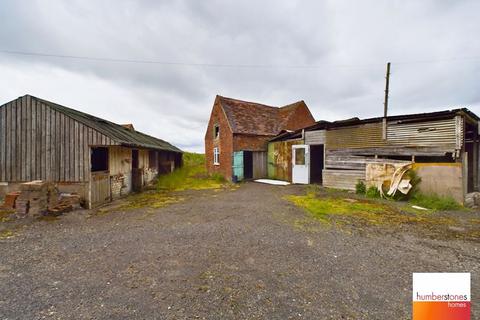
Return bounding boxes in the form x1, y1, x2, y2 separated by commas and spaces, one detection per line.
205, 95, 315, 181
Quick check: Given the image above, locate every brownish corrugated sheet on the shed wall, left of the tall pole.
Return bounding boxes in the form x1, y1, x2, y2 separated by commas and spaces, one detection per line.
325, 122, 385, 149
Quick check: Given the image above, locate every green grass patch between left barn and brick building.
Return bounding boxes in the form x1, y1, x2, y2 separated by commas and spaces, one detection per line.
157, 152, 226, 191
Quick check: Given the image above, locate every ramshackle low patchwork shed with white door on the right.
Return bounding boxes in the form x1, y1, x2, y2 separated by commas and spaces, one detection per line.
268, 108, 480, 202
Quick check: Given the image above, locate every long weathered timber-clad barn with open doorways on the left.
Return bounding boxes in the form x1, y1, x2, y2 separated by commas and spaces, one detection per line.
0, 95, 182, 207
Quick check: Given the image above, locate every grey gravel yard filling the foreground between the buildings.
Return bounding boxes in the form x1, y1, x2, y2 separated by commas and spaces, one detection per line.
0, 183, 480, 319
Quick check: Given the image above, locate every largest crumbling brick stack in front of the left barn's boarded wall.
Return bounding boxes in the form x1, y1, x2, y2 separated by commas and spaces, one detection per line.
15, 180, 57, 217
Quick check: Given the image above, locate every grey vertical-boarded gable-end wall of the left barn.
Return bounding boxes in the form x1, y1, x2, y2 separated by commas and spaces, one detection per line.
0, 96, 116, 182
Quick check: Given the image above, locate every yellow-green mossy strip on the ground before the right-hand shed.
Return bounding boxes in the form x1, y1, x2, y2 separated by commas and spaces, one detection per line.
286, 189, 480, 241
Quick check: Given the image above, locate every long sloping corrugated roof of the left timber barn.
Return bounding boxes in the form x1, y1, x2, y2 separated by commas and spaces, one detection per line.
27, 95, 182, 152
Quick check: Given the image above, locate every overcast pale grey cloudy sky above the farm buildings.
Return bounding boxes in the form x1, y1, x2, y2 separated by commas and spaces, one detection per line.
0, 0, 480, 152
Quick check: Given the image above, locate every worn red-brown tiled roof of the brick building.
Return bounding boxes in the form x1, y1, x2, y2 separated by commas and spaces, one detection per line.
217, 96, 312, 136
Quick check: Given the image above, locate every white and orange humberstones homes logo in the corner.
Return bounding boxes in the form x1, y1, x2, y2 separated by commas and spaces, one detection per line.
412, 273, 471, 320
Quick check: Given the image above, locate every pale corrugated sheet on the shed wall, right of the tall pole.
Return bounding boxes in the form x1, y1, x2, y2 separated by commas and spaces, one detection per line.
387, 118, 457, 149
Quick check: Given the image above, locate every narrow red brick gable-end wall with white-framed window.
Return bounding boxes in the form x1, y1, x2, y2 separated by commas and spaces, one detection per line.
205, 102, 233, 180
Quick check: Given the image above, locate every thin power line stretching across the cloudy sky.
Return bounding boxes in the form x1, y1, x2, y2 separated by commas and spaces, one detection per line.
0, 50, 480, 69
